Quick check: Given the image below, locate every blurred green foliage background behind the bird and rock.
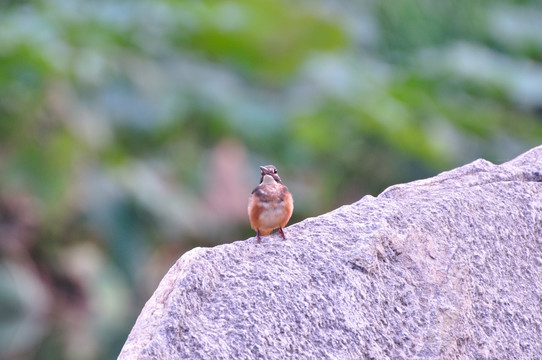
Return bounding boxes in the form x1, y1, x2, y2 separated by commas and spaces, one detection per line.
0, 0, 542, 359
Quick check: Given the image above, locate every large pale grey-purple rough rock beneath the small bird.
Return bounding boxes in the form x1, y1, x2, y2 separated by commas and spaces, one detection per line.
119, 147, 542, 359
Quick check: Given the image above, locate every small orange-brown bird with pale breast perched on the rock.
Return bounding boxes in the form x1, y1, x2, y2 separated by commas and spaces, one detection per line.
248, 165, 294, 242
